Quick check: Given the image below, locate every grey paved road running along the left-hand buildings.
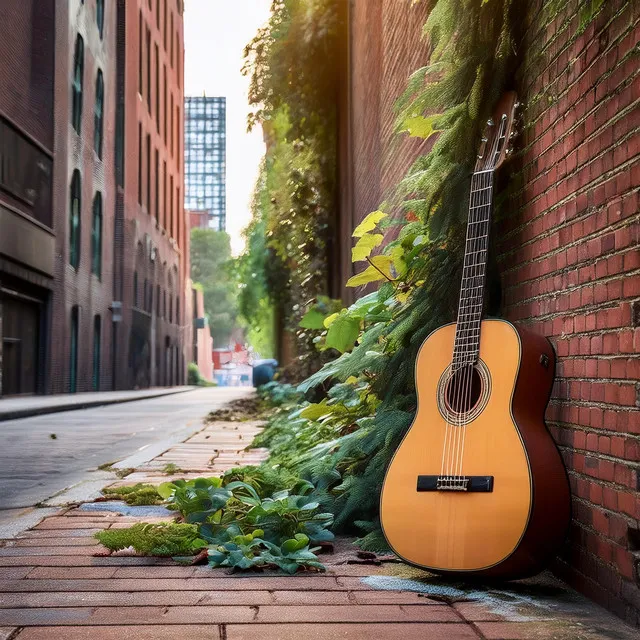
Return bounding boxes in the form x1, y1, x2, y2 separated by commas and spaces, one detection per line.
0, 387, 250, 521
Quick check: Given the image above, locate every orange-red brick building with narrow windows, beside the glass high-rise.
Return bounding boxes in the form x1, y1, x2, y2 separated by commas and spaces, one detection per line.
114, 0, 192, 388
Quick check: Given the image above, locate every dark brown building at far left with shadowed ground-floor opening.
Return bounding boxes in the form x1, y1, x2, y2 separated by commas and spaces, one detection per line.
0, 0, 55, 396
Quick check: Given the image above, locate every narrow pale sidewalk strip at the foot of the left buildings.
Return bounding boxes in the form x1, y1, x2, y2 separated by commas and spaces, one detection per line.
0, 386, 198, 422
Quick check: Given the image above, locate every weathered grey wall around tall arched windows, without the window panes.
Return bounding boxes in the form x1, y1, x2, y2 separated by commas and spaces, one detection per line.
46, 0, 116, 393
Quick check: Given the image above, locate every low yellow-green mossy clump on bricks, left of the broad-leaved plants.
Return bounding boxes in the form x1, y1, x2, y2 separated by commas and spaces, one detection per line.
95, 522, 207, 556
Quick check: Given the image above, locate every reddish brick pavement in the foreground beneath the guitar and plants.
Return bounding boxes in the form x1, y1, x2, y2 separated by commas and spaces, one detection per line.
0, 410, 636, 640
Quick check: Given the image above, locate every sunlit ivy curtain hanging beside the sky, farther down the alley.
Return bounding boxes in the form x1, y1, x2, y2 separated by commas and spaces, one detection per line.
241, 0, 341, 372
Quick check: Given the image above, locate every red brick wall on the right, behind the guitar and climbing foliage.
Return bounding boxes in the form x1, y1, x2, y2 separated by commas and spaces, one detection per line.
341, 0, 640, 624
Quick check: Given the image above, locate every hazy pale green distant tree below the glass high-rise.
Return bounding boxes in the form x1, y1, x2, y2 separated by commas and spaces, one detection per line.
191, 229, 238, 347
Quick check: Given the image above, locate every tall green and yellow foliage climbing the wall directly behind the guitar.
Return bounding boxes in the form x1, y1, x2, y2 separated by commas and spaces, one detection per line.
245, 0, 516, 550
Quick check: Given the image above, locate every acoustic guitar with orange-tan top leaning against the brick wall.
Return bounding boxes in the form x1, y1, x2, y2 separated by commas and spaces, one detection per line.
380, 93, 570, 579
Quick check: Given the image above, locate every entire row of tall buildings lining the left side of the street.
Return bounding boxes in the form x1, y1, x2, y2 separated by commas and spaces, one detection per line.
0, 0, 192, 396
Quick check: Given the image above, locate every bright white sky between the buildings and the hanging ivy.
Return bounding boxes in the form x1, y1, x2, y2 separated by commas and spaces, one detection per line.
184, 0, 271, 255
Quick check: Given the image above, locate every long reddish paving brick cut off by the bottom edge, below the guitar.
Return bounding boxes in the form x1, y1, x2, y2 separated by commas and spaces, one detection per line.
224, 623, 478, 640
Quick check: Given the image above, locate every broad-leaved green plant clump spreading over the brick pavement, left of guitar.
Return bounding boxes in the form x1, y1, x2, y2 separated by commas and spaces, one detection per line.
158, 468, 333, 573
